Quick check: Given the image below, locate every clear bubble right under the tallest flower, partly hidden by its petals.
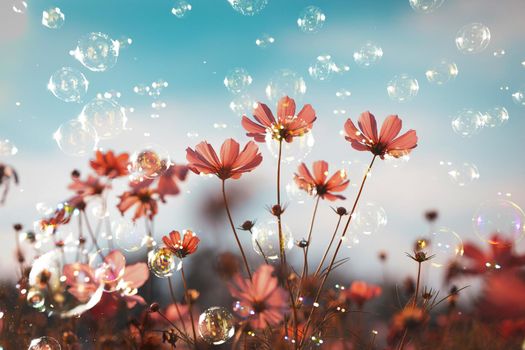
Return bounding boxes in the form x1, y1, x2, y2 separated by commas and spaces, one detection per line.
266, 131, 315, 164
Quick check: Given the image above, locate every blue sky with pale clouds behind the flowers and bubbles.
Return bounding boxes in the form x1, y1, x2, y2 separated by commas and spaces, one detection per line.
0, 0, 525, 288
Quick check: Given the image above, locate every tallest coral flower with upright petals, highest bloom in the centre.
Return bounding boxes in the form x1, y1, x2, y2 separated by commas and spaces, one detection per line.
242, 96, 317, 142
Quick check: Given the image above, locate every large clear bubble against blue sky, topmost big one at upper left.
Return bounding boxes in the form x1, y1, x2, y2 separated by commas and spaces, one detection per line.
72, 33, 120, 72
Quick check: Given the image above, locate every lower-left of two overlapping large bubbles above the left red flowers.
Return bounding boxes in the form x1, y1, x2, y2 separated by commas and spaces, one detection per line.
53, 119, 98, 157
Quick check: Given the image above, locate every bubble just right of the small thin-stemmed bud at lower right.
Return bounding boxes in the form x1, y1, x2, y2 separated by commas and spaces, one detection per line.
428, 227, 463, 267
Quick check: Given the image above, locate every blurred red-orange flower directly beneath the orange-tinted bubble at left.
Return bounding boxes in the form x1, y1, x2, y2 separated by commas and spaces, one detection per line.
117, 181, 158, 221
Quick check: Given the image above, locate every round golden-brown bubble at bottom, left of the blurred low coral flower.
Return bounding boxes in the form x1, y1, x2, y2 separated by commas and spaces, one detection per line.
199, 306, 235, 345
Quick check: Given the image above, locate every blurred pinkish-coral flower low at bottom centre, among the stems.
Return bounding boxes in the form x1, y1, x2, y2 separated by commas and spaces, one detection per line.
228, 265, 288, 329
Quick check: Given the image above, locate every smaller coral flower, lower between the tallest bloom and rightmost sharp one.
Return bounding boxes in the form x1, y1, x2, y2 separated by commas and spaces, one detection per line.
294, 160, 350, 201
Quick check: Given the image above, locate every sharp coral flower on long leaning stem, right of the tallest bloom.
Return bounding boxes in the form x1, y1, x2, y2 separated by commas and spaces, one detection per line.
345, 111, 417, 159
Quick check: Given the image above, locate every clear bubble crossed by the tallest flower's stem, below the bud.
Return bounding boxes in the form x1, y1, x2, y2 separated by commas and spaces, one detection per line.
252, 220, 294, 260
